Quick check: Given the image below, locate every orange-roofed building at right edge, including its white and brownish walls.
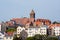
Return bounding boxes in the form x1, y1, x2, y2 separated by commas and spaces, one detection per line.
49, 24, 60, 36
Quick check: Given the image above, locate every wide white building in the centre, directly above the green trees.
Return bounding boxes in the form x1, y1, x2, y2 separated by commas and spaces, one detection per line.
27, 27, 40, 37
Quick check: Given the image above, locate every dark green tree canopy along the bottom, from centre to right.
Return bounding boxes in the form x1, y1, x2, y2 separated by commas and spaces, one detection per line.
26, 34, 58, 40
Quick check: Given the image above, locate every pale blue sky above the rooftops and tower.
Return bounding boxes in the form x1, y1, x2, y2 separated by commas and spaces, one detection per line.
0, 0, 60, 21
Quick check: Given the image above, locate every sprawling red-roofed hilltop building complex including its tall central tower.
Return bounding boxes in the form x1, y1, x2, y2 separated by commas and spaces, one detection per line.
6, 10, 51, 27
